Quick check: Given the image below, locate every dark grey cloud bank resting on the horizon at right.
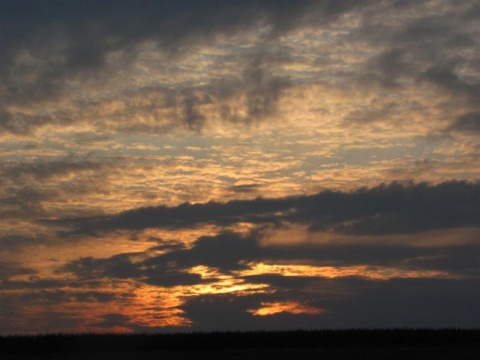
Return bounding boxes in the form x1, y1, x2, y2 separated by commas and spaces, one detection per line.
182, 278, 479, 331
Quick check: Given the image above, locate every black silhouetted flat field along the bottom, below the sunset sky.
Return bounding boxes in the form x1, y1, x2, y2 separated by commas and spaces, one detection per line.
0, 329, 480, 360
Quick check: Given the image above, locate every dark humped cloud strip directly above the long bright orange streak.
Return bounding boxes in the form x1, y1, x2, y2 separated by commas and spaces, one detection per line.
144, 233, 478, 280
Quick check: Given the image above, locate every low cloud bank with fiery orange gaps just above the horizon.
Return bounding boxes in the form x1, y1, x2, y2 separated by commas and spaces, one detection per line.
5, 221, 478, 331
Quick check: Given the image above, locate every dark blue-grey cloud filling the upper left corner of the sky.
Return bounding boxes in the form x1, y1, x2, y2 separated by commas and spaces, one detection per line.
0, 0, 363, 98
